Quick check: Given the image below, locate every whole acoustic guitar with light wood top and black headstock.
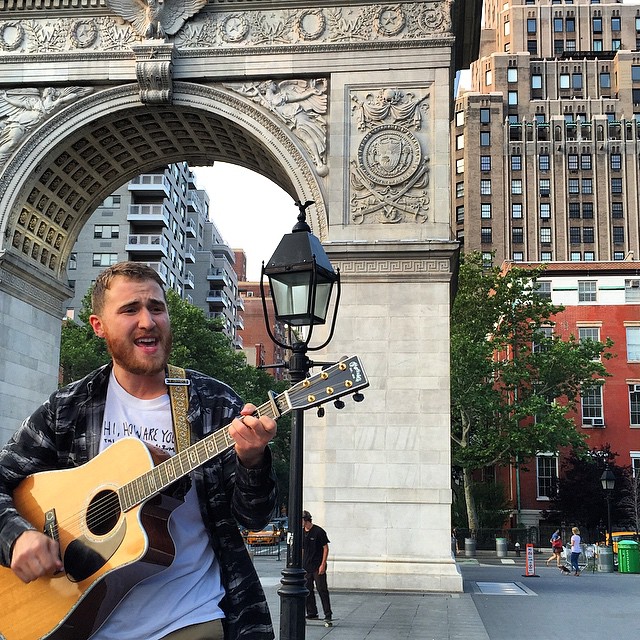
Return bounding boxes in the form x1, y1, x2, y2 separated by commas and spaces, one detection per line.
0, 356, 369, 640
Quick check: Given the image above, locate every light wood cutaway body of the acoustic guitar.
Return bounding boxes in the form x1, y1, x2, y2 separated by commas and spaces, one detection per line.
0, 438, 180, 640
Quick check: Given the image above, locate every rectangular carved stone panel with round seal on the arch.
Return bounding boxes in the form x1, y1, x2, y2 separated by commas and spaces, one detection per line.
350, 88, 429, 224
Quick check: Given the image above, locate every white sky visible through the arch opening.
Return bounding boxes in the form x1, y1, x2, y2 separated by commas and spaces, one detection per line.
192, 162, 298, 282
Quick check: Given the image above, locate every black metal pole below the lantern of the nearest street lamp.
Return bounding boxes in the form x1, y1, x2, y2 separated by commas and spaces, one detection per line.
278, 342, 310, 640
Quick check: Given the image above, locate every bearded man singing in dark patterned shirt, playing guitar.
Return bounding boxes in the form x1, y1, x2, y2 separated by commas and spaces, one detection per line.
0, 262, 277, 640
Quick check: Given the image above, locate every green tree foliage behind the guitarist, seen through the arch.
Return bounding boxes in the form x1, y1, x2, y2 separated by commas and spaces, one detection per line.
60, 290, 291, 501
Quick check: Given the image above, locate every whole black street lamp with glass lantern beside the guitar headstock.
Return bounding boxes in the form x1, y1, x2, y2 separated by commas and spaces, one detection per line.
260, 202, 340, 640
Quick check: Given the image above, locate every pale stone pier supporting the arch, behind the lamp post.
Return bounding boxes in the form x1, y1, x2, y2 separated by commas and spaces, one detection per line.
304, 241, 462, 592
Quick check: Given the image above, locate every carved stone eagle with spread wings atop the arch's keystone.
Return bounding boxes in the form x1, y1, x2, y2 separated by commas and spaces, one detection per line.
107, 0, 208, 38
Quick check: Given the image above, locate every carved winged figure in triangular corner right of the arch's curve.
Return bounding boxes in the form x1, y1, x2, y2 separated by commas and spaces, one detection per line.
224, 79, 328, 176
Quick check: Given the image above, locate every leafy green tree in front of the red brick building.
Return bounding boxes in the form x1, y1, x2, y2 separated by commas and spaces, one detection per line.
451, 253, 610, 531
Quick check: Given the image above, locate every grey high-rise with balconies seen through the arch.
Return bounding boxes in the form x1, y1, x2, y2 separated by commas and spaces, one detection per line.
67, 163, 243, 348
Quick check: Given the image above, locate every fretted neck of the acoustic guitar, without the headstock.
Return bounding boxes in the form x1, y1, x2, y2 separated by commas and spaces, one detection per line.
118, 392, 291, 511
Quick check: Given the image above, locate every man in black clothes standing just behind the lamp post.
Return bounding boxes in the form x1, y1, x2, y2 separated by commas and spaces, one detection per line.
302, 511, 332, 622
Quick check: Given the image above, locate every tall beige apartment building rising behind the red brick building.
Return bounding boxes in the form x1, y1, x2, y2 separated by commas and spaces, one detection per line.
451, 0, 640, 264
